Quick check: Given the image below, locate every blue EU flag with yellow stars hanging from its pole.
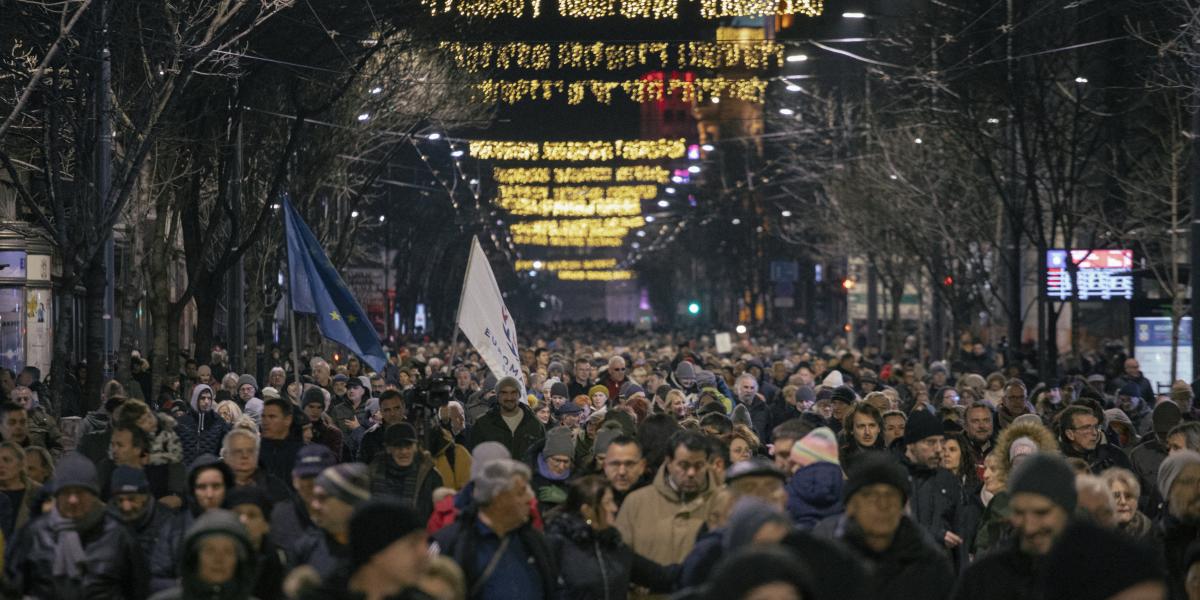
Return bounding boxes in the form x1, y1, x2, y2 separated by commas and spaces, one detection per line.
283, 199, 388, 372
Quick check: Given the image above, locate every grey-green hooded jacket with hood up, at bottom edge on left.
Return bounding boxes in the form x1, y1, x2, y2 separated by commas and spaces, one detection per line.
151, 510, 257, 600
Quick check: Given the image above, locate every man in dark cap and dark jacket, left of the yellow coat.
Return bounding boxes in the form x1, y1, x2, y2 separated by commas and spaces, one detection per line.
371, 422, 442, 521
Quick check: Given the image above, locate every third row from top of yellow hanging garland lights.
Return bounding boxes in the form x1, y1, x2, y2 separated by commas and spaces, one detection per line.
473, 77, 767, 104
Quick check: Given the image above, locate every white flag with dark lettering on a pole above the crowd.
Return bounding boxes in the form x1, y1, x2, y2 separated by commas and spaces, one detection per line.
457, 238, 524, 386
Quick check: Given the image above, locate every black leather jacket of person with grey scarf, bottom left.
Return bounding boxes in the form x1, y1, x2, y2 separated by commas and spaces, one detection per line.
5, 506, 148, 600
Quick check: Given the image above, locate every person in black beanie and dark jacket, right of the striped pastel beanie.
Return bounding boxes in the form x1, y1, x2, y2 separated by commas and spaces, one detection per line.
812, 454, 954, 600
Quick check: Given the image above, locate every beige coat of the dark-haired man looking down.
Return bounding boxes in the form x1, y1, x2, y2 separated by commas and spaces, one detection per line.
617, 464, 718, 565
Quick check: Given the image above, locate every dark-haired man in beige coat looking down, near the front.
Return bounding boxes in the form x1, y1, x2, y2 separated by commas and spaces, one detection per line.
617, 430, 718, 564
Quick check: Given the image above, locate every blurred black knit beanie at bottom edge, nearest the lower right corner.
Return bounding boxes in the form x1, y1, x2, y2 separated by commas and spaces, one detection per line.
1044, 522, 1166, 600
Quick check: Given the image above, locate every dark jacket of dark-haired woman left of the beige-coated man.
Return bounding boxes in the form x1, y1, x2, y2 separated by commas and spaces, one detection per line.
546, 512, 673, 600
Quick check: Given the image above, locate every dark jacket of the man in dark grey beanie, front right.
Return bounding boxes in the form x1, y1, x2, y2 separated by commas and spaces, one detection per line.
954, 536, 1045, 600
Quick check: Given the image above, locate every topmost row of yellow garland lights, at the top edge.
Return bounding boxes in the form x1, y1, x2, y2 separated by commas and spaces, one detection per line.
421, 0, 824, 19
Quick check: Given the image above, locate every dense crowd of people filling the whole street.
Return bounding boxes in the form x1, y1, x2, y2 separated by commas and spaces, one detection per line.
0, 330, 1200, 600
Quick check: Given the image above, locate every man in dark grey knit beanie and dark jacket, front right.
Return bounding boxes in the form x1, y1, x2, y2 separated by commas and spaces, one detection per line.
954, 452, 1080, 600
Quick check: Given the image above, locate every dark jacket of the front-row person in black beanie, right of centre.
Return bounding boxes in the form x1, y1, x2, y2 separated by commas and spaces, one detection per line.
812, 515, 955, 600
